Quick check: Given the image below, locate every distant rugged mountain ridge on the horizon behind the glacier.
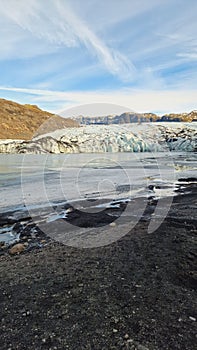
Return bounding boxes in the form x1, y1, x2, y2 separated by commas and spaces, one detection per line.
73, 111, 197, 125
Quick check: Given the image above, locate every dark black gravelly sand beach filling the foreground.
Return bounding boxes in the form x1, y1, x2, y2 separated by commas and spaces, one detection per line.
0, 184, 197, 350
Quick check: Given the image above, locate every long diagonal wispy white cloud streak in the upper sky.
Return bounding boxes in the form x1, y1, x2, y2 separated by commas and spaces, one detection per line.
1, 0, 135, 81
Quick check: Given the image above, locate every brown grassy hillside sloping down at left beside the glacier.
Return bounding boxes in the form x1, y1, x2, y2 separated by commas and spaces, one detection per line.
0, 99, 78, 140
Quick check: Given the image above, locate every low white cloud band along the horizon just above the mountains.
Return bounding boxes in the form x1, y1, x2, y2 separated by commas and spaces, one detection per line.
0, 87, 197, 114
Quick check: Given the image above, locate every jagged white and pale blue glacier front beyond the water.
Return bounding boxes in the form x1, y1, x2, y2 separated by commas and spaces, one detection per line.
0, 123, 197, 154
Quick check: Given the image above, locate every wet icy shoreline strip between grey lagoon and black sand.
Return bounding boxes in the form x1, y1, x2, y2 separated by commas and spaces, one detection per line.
0, 177, 197, 250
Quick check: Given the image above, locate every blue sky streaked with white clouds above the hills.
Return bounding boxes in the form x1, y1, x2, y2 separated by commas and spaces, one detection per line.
0, 0, 197, 114
